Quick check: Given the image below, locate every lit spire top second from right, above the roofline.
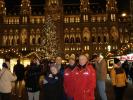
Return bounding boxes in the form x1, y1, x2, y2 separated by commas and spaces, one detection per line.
80, 0, 90, 12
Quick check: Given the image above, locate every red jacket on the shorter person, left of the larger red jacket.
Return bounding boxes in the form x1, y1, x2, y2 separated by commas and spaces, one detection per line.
64, 68, 74, 97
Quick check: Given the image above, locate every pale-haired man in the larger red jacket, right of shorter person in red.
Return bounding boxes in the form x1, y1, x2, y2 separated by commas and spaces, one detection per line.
73, 55, 96, 100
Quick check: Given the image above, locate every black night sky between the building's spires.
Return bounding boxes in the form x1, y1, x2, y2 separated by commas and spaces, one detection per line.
5, 0, 130, 11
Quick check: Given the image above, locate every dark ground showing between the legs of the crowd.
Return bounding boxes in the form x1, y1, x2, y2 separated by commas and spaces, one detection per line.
11, 81, 133, 100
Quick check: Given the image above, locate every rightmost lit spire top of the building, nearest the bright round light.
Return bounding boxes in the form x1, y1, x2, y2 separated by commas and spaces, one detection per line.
106, 0, 118, 12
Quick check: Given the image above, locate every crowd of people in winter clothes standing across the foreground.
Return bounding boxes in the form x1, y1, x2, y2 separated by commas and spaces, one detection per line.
0, 54, 133, 100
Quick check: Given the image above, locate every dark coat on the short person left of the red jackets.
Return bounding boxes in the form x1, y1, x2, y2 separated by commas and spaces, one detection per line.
44, 73, 63, 100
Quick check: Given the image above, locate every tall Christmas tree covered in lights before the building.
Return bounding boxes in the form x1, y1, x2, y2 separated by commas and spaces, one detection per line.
42, 15, 58, 58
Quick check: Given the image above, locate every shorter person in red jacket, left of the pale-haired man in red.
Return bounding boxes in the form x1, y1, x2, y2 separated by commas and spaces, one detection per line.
64, 57, 76, 100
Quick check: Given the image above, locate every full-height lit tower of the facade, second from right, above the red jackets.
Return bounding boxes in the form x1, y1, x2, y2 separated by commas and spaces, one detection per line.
80, 0, 92, 52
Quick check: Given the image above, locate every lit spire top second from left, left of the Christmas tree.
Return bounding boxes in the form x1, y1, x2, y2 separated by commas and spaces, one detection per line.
20, 0, 31, 15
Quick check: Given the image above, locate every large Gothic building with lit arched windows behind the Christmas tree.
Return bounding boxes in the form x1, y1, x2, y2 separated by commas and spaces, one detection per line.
0, 0, 130, 57
